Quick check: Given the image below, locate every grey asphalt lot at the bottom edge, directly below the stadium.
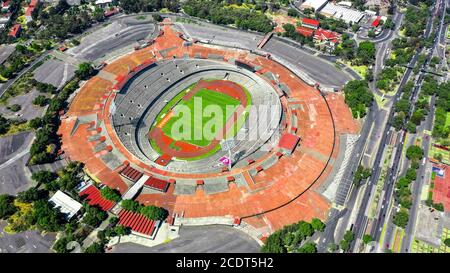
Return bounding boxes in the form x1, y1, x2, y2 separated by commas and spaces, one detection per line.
111, 226, 260, 253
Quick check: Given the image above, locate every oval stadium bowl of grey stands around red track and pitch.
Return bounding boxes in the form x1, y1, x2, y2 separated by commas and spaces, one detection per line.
111, 58, 282, 173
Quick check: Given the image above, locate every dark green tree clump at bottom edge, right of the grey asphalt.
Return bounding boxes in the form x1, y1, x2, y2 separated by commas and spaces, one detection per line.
261, 218, 325, 253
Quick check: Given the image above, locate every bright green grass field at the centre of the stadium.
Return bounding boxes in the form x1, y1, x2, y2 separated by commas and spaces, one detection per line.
162, 89, 240, 147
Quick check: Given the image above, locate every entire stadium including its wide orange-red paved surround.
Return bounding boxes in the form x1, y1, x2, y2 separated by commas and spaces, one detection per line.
59, 19, 359, 238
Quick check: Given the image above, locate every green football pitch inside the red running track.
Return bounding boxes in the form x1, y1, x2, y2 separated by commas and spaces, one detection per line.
162, 89, 241, 147
